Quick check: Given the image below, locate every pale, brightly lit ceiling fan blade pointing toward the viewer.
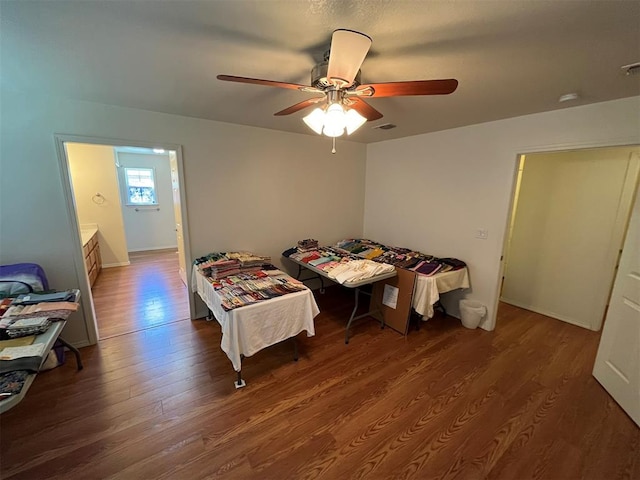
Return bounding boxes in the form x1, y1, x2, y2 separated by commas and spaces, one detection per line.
327, 29, 371, 88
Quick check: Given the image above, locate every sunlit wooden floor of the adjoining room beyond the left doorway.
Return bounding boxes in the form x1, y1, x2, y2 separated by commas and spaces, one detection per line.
91, 249, 189, 338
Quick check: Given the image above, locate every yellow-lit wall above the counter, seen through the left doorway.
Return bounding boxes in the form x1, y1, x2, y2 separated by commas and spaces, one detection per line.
66, 143, 129, 267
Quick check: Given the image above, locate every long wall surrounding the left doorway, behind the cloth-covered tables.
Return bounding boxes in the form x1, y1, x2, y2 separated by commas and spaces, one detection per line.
0, 89, 366, 346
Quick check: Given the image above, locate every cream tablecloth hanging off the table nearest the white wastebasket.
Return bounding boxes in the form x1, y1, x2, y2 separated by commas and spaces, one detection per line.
411, 268, 469, 318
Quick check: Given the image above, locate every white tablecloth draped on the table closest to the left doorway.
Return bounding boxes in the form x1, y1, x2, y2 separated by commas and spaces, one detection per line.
192, 268, 320, 372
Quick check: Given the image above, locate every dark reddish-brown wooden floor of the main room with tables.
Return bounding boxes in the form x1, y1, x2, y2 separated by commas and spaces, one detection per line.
0, 287, 640, 480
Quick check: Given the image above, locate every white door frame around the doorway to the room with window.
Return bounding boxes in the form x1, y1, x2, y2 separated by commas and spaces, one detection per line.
54, 134, 195, 345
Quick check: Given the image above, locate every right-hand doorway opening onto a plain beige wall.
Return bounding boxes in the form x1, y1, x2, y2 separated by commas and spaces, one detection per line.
500, 146, 640, 330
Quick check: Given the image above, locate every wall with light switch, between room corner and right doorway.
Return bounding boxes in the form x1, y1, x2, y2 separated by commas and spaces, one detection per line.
364, 97, 640, 329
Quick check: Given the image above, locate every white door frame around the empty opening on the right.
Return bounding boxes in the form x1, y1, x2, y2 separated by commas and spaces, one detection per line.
490, 140, 640, 330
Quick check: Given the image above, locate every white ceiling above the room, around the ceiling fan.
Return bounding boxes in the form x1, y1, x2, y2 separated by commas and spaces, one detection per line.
0, 0, 640, 143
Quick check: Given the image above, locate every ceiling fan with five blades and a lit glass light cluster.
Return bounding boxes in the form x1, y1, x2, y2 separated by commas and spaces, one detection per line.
217, 29, 458, 141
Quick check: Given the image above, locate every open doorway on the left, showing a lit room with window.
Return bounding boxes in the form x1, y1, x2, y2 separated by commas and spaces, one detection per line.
58, 139, 193, 339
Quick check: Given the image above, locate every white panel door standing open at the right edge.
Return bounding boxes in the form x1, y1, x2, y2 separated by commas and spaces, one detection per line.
593, 185, 640, 425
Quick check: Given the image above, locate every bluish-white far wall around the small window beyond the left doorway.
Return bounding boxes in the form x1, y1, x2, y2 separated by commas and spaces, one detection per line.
116, 152, 178, 252
